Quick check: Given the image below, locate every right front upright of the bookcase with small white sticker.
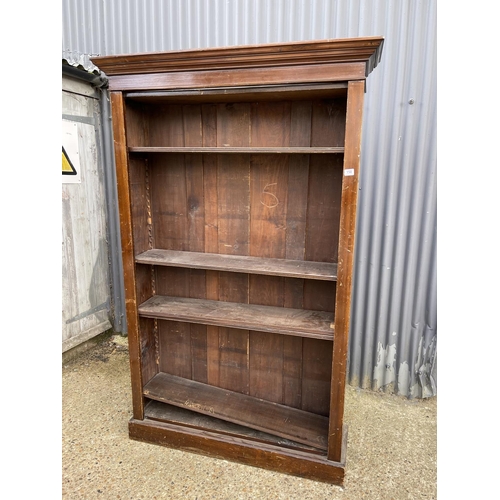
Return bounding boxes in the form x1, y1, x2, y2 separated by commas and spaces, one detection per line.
328, 81, 365, 461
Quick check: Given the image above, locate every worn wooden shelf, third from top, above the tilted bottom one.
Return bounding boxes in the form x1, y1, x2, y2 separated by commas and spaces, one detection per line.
138, 295, 334, 340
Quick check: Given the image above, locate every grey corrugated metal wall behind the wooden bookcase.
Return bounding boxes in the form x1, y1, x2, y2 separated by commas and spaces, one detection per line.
63, 0, 437, 397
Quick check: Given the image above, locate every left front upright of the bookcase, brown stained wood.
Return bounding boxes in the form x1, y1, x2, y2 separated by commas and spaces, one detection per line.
110, 92, 144, 420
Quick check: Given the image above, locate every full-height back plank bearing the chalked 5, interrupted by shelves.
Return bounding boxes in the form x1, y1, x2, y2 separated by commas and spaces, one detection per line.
249, 102, 290, 403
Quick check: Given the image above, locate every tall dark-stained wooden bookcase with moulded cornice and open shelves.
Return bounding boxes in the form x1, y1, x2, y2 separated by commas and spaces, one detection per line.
93, 37, 383, 484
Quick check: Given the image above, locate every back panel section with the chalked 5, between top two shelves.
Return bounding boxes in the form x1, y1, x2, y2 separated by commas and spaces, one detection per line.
146, 153, 342, 262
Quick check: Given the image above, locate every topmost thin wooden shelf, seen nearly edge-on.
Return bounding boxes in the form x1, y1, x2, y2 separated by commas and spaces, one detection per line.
128, 146, 344, 154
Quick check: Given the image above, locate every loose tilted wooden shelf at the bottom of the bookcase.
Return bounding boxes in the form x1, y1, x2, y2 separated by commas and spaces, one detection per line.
143, 372, 328, 450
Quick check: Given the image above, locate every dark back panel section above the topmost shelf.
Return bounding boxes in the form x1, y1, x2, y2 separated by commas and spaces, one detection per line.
127, 99, 346, 147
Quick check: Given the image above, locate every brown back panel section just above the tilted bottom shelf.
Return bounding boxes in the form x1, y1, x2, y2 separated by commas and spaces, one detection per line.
158, 320, 332, 416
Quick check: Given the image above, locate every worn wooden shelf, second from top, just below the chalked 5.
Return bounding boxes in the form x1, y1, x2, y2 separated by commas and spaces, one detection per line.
135, 249, 337, 281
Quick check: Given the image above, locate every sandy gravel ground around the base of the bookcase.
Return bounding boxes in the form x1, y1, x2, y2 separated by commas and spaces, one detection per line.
62, 336, 437, 500
